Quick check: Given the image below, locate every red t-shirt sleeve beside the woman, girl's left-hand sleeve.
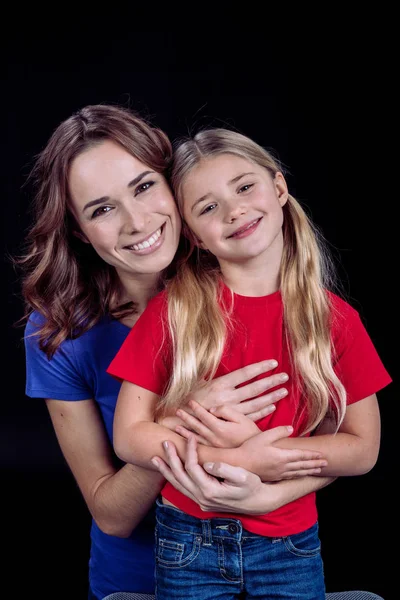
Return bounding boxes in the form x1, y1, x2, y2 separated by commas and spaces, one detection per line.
107, 292, 171, 396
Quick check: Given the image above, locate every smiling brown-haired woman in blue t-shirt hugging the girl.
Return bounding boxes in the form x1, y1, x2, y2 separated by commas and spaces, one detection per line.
20, 105, 332, 600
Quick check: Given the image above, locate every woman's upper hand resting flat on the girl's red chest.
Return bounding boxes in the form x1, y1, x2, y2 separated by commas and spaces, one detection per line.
187, 360, 289, 421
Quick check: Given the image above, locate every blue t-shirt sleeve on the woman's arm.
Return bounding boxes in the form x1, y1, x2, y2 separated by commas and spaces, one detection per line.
24, 313, 93, 400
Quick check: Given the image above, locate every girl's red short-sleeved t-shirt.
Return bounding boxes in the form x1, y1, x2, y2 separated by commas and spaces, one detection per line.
107, 286, 391, 536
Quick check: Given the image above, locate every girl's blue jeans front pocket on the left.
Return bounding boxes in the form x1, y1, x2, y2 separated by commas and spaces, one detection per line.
156, 523, 202, 569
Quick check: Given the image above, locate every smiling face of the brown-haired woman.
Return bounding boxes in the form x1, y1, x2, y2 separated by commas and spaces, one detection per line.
69, 140, 181, 279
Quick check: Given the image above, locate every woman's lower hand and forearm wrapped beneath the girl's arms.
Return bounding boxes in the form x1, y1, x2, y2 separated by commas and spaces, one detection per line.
153, 437, 334, 514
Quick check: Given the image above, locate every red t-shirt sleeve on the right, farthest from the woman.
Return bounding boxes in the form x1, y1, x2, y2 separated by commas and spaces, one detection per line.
333, 298, 392, 404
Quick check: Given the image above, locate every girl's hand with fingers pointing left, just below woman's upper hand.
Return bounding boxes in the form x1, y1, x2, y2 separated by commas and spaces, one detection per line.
175, 400, 260, 448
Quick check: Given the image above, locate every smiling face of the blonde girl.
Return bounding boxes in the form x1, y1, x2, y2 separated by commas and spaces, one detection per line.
182, 154, 288, 267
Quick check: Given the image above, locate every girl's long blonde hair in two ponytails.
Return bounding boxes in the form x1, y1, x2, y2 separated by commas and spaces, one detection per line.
158, 129, 346, 434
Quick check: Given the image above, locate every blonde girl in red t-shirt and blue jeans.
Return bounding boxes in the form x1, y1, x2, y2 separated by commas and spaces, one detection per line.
109, 129, 390, 600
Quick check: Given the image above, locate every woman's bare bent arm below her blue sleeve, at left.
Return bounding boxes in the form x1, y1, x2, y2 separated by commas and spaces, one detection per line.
46, 400, 164, 537
